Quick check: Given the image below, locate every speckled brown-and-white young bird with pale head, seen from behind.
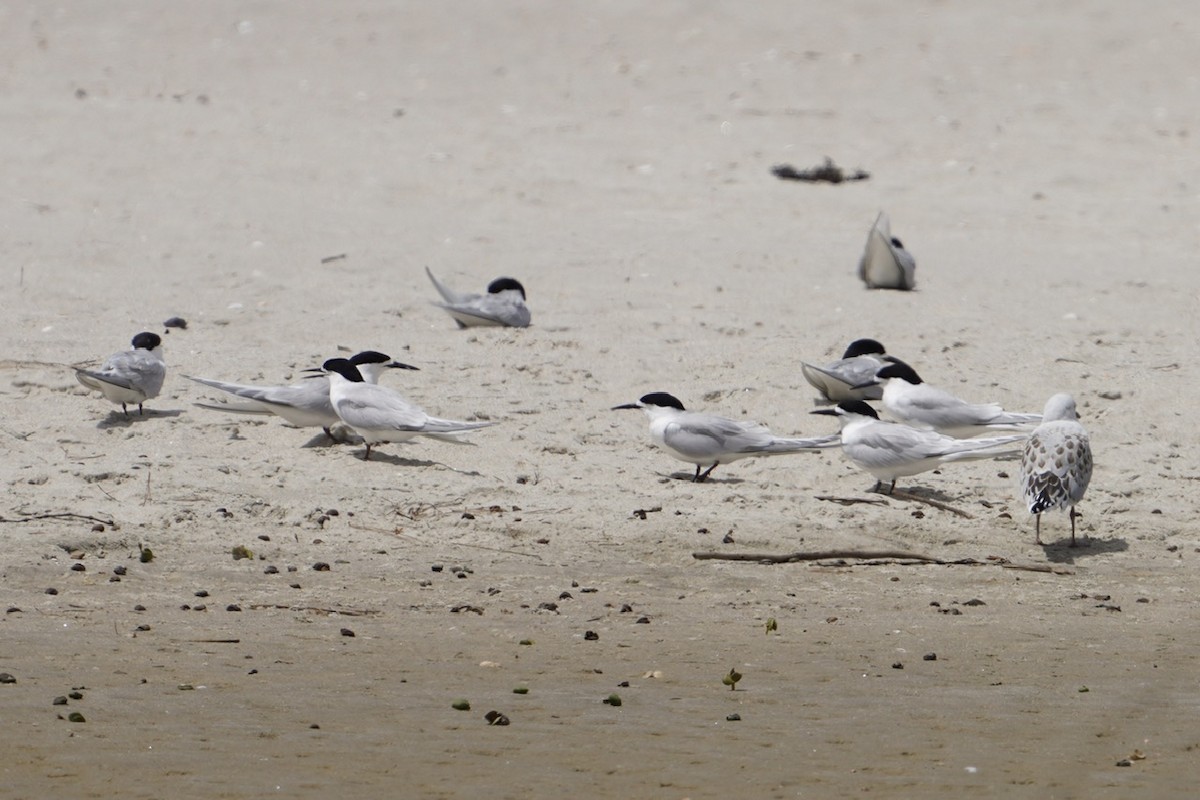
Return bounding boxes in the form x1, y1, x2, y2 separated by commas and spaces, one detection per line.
1021, 395, 1092, 547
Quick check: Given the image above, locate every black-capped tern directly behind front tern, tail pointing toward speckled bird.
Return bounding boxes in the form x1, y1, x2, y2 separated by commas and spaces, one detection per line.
868, 359, 1042, 439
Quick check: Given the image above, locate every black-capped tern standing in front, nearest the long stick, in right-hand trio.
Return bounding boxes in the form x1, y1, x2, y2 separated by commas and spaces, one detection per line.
811, 401, 1025, 494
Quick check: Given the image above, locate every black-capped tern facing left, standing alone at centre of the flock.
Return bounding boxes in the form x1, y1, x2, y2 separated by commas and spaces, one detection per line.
613, 392, 838, 483
